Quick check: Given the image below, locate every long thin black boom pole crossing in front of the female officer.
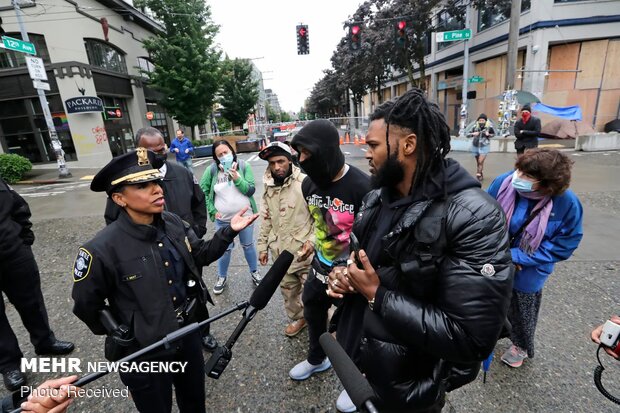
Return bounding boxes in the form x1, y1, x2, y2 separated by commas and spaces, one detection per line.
10, 301, 250, 413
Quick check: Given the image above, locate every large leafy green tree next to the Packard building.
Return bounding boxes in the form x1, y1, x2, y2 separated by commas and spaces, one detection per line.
134, 0, 220, 136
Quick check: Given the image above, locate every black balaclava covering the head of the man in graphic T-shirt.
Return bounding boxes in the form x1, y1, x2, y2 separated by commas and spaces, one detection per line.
291, 119, 344, 184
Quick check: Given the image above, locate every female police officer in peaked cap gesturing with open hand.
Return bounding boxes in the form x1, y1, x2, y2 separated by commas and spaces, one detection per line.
72, 148, 257, 413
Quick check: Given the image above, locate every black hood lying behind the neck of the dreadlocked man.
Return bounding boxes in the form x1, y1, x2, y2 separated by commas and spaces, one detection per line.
382, 159, 482, 206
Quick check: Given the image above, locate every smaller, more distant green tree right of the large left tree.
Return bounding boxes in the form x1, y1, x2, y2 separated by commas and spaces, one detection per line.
219, 57, 258, 125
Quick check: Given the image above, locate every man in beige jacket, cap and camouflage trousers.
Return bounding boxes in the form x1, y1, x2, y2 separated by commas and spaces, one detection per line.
257, 142, 314, 337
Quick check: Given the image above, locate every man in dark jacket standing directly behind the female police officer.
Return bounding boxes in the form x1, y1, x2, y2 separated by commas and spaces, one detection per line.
104, 127, 218, 351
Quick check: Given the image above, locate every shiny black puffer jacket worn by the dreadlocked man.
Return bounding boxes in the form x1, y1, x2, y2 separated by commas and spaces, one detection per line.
348, 161, 514, 411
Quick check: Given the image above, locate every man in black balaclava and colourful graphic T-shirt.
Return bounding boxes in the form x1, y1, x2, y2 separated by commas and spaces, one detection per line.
289, 119, 370, 380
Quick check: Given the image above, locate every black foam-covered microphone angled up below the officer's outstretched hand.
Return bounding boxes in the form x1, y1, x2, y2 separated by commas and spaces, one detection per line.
205, 250, 294, 379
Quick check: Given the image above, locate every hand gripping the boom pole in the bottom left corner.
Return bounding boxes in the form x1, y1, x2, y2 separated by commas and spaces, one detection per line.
20, 376, 78, 413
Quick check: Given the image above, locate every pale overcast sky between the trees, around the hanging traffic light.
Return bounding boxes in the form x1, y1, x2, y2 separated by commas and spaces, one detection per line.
211, 0, 361, 112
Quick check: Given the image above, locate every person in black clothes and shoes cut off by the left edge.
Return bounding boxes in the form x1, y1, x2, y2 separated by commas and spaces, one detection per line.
0, 178, 74, 391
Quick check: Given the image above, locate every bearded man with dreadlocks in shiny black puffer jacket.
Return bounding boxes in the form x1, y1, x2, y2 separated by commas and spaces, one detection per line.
328, 89, 514, 412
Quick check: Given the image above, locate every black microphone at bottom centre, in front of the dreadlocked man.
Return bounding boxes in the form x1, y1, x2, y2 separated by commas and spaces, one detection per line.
319, 333, 377, 413
